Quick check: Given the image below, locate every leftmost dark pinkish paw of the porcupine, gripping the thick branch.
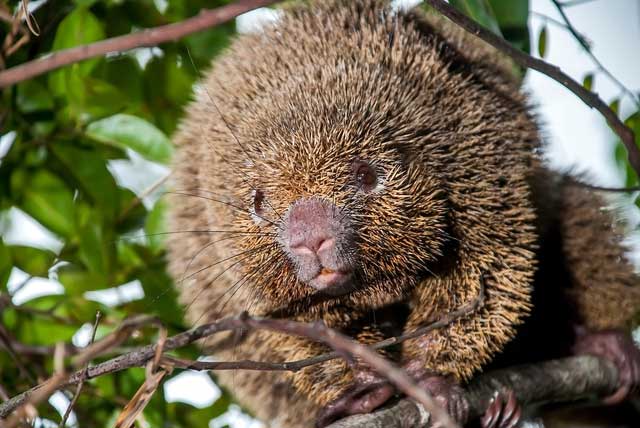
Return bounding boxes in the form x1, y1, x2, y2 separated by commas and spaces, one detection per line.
316, 379, 395, 428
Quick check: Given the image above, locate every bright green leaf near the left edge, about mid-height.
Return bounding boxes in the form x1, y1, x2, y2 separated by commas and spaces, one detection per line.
12, 169, 74, 238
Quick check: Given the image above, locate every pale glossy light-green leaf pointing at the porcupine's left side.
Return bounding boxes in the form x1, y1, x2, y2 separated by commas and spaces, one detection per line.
86, 114, 173, 163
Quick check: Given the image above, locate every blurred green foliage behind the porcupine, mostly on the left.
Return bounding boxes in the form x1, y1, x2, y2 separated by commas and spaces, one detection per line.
0, 0, 640, 427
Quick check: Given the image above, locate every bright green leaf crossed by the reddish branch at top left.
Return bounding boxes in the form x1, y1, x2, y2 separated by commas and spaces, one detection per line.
49, 7, 105, 96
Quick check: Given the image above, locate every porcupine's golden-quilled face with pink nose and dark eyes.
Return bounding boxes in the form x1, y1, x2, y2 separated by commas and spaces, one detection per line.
224, 102, 446, 305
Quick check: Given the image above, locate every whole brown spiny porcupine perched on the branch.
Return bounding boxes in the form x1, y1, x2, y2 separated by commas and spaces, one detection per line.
168, 0, 640, 427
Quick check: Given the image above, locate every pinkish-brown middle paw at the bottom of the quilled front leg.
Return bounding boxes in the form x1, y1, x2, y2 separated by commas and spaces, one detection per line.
412, 370, 469, 424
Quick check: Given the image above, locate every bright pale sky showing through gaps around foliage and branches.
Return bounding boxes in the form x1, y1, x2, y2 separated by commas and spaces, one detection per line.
0, 0, 640, 428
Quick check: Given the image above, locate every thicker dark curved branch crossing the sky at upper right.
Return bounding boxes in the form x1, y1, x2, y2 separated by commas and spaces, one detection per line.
425, 0, 640, 179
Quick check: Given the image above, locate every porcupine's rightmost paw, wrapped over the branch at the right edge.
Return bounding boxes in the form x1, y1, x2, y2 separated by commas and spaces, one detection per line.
573, 329, 640, 404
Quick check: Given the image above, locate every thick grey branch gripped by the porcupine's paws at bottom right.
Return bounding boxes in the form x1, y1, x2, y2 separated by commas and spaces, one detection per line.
327, 356, 618, 428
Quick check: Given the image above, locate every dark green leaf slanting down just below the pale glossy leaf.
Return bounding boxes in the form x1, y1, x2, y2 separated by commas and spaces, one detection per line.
50, 142, 119, 220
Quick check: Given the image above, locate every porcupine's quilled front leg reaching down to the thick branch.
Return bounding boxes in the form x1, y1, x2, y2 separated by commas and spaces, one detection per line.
402, 265, 528, 427
